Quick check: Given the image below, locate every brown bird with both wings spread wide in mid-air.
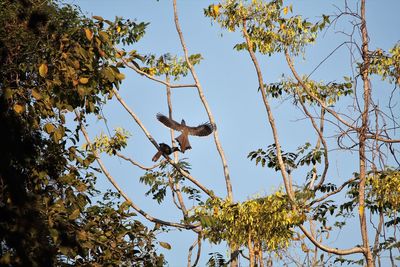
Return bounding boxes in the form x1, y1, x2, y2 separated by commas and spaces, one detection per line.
157, 113, 214, 153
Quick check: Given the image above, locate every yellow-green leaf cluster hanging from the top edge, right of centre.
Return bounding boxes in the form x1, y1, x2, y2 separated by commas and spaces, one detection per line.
204, 0, 330, 55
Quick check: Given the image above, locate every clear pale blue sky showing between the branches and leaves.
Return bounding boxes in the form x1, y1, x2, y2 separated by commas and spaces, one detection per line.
67, 0, 400, 266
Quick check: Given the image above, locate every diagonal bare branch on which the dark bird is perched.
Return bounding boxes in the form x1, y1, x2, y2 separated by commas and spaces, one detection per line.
113, 88, 215, 198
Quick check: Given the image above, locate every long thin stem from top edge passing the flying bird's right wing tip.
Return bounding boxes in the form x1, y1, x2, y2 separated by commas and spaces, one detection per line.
173, 0, 233, 200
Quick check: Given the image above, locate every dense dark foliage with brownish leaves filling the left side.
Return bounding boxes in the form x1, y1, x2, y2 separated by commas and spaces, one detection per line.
0, 0, 164, 266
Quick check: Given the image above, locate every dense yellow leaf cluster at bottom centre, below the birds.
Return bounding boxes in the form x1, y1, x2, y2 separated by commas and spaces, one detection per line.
195, 191, 305, 251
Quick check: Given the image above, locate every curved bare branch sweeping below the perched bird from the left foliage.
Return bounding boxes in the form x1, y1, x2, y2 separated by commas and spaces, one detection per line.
75, 111, 197, 229
